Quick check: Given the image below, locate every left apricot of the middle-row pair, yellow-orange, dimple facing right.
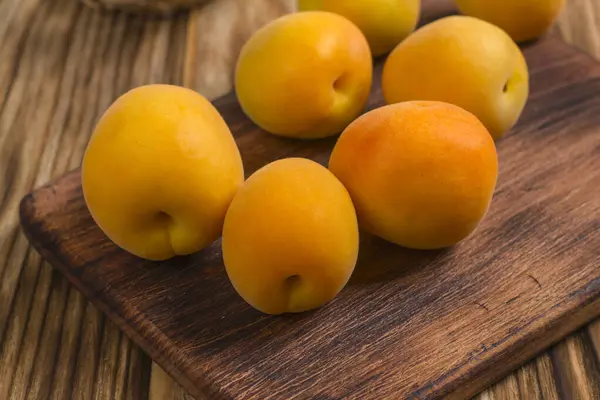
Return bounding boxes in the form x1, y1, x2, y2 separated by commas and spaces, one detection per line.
235, 11, 373, 139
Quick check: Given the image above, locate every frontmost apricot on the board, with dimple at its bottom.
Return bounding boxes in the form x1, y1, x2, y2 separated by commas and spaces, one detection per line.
222, 158, 358, 314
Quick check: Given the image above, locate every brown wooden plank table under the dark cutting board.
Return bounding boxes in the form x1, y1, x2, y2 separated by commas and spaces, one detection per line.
0, 0, 600, 400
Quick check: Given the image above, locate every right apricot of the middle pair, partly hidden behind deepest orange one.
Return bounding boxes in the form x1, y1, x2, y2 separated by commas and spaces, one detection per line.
381, 15, 529, 139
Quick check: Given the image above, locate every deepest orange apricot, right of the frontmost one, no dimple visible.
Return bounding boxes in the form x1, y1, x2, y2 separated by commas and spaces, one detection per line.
329, 101, 498, 249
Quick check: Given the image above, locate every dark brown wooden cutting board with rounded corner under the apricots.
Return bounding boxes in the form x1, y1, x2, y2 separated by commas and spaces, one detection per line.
21, 29, 600, 399
